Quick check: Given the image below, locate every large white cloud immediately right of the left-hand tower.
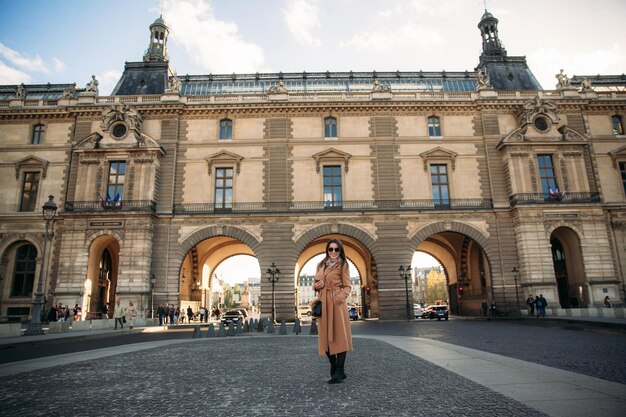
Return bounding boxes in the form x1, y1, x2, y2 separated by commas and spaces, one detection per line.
164, 0, 265, 73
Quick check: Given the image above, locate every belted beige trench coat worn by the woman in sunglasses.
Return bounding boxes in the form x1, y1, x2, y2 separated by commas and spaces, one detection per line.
315, 263, 352, 356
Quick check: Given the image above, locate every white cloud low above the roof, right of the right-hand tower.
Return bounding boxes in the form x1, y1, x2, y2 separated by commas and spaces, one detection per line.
528, 43, 626, 90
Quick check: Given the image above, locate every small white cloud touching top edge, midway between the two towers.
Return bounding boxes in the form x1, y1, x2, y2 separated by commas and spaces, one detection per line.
283, 0, 321, 46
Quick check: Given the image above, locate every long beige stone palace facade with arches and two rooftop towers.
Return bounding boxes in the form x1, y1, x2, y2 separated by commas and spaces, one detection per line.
0, 12, 626, 319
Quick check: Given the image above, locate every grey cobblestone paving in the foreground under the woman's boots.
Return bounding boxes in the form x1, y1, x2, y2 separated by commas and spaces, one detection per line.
0, 336, 543, 417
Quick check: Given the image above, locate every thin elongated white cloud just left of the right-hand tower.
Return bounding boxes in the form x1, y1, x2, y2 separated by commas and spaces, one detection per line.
340, 23, 442, 51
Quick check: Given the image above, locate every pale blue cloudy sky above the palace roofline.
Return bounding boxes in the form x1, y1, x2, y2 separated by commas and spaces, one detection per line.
0, 0, 626, 95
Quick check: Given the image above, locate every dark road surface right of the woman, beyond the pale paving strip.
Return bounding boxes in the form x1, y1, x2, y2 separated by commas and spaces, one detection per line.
352, 319, 626, 384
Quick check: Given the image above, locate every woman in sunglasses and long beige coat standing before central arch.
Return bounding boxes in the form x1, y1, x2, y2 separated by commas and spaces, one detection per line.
313, 239, 352, 384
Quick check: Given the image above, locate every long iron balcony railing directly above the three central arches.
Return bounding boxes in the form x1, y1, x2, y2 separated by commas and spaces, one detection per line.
174, 198, 493, 214
